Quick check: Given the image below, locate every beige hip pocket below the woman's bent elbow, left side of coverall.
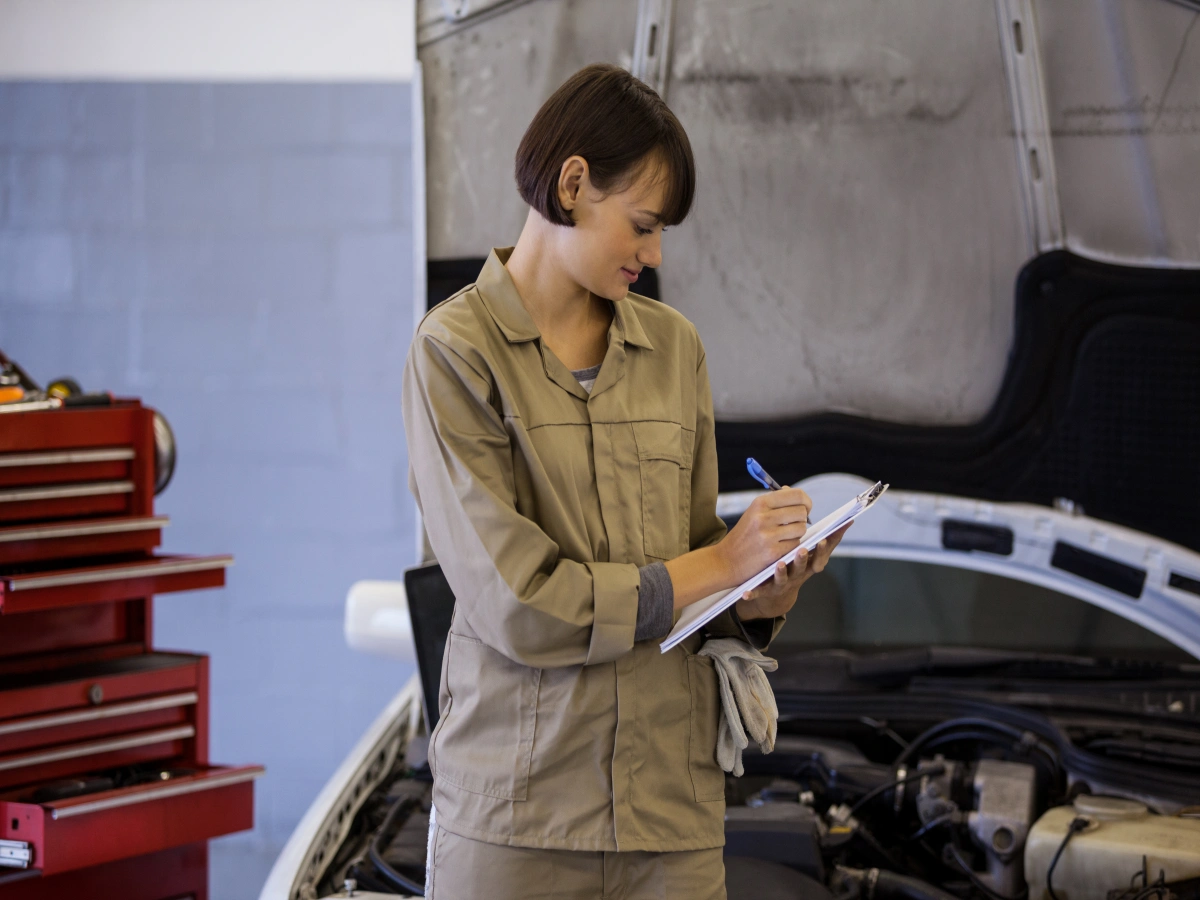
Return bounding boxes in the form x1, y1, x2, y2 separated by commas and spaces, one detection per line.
430, 631, 541, 800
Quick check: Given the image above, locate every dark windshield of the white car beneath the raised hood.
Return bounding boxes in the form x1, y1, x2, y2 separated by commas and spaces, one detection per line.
772, 557, 1195, 662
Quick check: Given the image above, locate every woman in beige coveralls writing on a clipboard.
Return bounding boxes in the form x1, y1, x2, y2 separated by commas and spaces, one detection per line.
403, 65, 840, 900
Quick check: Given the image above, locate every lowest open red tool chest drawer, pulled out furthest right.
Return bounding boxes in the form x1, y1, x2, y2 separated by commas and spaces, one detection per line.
0, 766, 263, 876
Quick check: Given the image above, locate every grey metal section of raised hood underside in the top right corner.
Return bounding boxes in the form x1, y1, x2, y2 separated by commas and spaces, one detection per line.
1037, 0, 1200, 265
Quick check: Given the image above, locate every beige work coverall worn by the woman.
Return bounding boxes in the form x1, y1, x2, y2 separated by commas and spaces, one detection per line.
403, 250, 782, 900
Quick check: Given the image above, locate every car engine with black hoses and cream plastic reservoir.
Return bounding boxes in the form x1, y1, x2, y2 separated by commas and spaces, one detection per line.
318, 715, 1200, 900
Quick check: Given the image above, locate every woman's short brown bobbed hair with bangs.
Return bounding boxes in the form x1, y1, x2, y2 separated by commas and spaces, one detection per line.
516, 64, 696, 226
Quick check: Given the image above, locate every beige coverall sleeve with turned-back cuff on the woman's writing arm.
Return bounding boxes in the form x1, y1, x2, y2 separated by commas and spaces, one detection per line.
402, 331, 638, 668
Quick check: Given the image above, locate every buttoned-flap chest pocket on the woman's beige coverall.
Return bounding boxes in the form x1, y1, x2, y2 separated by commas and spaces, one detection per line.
634, 421, 694, 559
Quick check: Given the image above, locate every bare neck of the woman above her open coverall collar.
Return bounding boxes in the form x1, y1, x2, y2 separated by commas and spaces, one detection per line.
505, 210, 612, 368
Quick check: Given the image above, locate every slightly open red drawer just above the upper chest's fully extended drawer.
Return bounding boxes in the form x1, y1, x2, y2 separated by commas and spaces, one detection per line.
0, 516, 169, 571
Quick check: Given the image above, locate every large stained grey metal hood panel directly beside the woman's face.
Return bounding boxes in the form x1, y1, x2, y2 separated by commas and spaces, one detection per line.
661, 0, 1031, 424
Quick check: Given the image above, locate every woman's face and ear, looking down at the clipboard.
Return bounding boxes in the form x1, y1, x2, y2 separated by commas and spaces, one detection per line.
557, 156, 666, 300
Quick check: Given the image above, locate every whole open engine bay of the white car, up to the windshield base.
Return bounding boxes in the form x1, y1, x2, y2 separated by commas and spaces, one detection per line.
317, 650, 1200, 900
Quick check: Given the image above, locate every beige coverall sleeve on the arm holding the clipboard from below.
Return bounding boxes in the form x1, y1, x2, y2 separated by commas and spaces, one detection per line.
691, 337, 786, 650
